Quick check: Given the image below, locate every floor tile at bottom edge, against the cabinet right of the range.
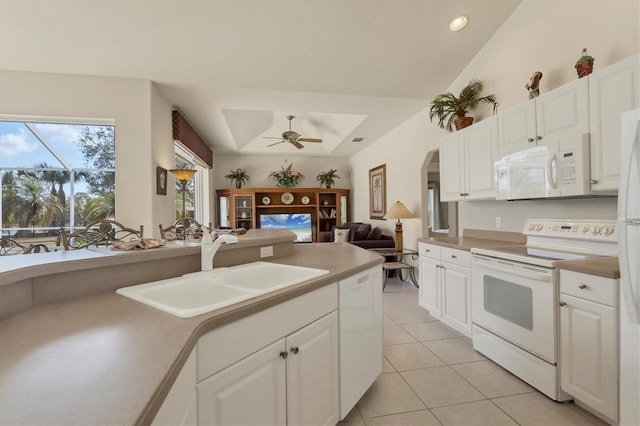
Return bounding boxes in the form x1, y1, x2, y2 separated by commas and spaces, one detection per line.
492, 392, 597, 426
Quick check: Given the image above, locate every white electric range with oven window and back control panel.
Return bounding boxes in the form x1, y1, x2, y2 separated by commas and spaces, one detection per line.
471, 219, 617, 401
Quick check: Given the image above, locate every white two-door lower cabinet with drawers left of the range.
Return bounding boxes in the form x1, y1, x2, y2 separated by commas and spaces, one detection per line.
418, 243, 471, 337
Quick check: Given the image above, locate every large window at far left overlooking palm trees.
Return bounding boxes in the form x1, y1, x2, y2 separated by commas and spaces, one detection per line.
0, 116, 115, 243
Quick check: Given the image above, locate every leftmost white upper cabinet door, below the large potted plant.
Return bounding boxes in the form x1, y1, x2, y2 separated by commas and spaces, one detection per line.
440, 131, 466, 201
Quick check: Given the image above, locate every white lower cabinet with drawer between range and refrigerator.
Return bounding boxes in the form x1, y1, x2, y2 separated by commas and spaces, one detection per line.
559, 270, 618, 423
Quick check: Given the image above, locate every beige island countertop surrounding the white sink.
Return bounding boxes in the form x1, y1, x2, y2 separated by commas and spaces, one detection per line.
0, 233, 382, 424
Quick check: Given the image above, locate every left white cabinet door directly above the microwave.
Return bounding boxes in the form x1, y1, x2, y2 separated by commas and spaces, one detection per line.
498, 99, 536, 157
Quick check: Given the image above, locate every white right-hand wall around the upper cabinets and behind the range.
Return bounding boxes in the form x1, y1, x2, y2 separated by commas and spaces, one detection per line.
349, 0, 640, 248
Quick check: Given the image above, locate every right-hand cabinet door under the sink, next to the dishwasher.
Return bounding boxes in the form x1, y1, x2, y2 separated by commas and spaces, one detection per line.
288, 312, 340, 426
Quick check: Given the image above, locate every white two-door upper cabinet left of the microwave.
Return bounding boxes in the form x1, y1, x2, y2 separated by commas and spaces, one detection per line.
440, 116, 498, 201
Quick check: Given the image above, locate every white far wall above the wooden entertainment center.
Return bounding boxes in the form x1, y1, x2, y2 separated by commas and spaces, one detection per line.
214, 155, 352, 189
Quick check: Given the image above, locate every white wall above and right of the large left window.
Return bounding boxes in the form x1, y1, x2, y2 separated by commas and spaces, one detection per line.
0, 71, 174, 236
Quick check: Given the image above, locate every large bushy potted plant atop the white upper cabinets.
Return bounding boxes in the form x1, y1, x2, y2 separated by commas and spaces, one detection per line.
429, 78, 496, 132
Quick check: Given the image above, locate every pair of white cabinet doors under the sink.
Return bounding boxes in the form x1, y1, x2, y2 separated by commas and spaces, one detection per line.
197, 312, 339, 425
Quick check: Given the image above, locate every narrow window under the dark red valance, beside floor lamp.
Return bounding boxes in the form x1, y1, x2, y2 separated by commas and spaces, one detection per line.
175, 143, 209, 224
